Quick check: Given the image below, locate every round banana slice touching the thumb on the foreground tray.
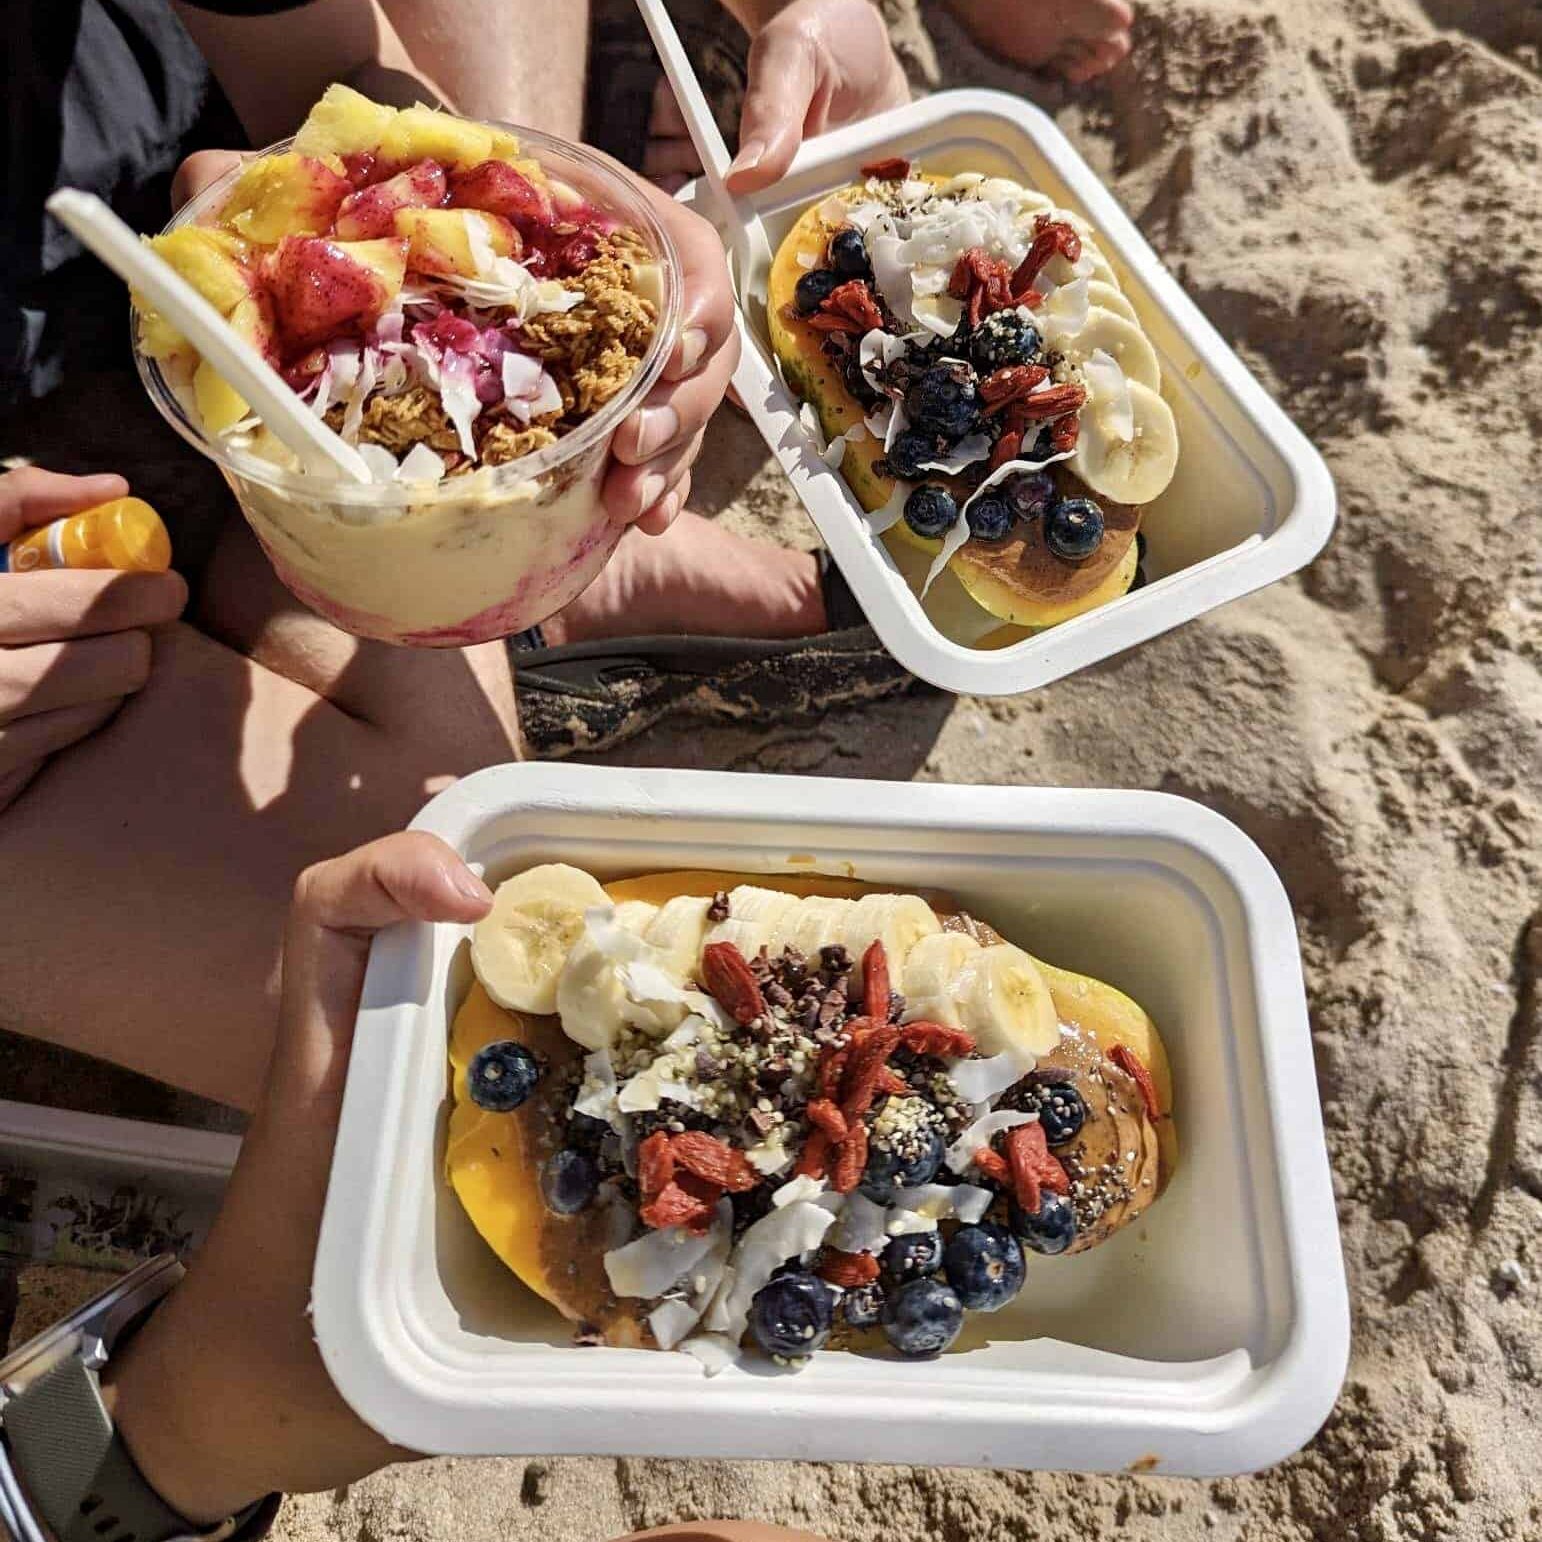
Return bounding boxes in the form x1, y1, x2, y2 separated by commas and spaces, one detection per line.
472, 862, 611, 1013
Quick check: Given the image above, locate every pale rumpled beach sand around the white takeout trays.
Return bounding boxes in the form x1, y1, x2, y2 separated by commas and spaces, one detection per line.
12, 0, 1542, 1542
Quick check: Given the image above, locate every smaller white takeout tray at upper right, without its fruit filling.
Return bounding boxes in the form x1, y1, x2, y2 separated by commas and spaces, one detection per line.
682, 91, 1337, 695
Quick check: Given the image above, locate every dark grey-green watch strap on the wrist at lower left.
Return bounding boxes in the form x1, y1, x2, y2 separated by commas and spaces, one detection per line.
5, 1355, 198, 1542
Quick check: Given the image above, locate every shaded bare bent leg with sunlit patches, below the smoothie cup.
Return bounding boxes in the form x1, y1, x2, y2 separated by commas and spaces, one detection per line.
0, 527, 515, 1109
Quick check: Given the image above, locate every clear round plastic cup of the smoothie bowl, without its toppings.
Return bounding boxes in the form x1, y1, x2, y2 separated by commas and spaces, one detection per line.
133, 123, 682, 648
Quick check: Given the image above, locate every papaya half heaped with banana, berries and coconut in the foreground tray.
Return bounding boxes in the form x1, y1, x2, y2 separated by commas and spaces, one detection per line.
447, 864, 1175, 1371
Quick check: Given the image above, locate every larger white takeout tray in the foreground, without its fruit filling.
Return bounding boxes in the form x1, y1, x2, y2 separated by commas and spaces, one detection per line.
313, 765, 1349, 1474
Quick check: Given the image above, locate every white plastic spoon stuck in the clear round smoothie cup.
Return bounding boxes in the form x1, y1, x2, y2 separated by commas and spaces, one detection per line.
48, 188, 372, 483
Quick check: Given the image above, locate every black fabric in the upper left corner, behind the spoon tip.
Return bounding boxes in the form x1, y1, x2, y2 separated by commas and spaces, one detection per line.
0, 0, 245, 575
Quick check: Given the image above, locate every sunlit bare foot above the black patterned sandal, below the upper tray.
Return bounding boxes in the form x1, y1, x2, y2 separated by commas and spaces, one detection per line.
541, 513, 827, 646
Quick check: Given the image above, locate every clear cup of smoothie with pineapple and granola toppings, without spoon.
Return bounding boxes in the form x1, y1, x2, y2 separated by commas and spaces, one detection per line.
133, 86, 682, 648
